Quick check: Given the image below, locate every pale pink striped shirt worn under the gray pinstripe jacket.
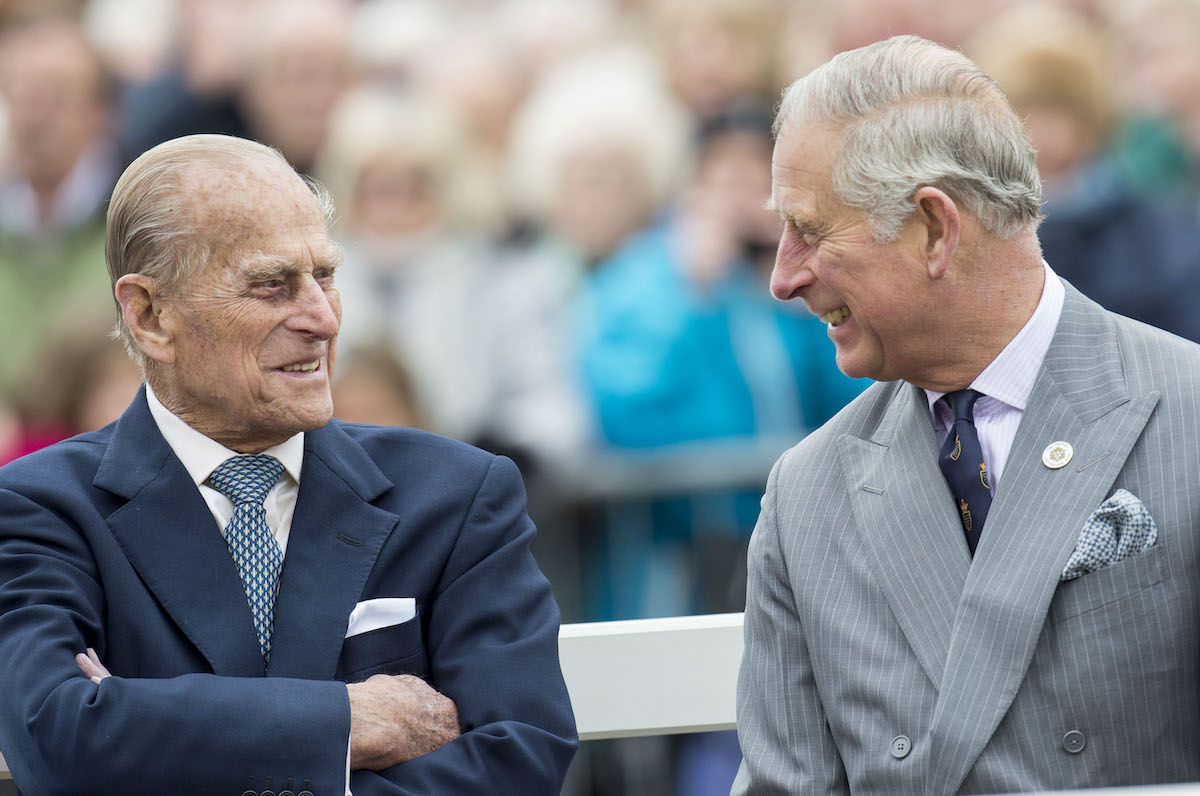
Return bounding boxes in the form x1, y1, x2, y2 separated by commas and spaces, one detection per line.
925, 261, 1066, 495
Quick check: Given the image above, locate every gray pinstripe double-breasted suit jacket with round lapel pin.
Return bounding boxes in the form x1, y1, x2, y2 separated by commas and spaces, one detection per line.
733, 285, 1200, 795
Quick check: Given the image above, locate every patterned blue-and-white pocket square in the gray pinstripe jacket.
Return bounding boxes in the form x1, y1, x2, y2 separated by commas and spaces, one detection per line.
1060, 489, 1158, 580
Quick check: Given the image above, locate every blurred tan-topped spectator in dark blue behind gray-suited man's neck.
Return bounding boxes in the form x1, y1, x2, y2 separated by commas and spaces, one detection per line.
968, 4, 1200, 340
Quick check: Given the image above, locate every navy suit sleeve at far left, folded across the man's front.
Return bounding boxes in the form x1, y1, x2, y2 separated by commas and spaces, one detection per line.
0, 490, 349, 796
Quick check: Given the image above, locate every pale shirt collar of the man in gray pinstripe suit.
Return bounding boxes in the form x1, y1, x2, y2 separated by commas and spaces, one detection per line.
925, 261, 1067, 412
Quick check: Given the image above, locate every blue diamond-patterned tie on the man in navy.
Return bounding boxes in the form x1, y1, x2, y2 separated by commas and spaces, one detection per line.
209, 454, 283, 665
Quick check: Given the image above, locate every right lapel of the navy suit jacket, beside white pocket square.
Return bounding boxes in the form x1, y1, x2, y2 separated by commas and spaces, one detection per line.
266, 423, 398, 680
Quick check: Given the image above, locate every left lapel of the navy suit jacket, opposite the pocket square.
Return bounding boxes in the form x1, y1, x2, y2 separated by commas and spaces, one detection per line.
94, 388, 263, 677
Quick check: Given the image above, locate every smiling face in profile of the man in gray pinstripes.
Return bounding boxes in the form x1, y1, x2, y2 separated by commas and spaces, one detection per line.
770, 122, 944, 384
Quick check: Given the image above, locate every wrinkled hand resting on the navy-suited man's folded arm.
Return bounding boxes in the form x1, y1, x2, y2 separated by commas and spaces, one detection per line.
350, 677, 461, 771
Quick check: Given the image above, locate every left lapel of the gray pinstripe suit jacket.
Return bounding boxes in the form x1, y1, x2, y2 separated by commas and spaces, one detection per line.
840, 383, 971, 688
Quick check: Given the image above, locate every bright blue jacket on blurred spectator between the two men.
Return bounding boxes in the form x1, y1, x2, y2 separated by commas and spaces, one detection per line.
576, 225, 870, 448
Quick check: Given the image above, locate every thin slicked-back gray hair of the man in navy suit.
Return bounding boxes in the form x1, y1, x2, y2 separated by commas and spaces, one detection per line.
104, 134, 334, 369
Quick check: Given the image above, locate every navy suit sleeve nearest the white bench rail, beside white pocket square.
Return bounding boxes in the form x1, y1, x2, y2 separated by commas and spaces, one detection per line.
350, 457, 577, 796
